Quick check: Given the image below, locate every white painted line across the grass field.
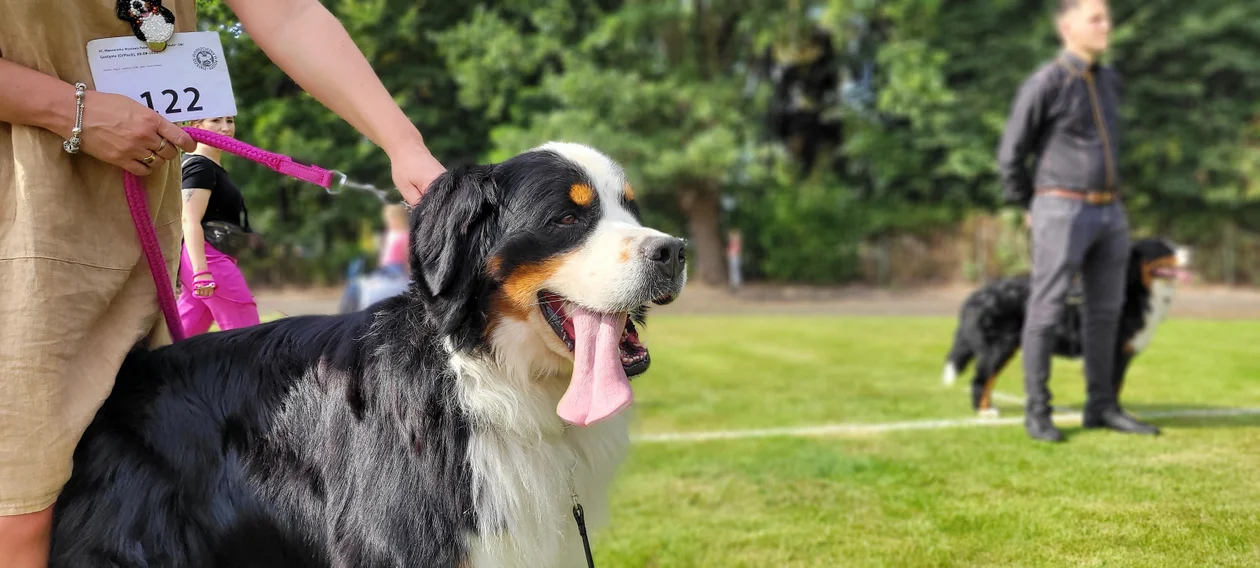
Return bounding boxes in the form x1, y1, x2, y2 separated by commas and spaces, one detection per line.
633, 408, 1260, 443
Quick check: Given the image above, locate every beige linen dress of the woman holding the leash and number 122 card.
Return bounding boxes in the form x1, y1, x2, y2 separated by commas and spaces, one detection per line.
0, 0, 197, 515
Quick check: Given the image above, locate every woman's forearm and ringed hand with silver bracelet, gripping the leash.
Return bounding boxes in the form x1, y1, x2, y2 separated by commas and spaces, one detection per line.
0, 58, 197, 175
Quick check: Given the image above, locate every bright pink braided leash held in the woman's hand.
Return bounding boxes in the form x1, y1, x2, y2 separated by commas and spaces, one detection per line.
123, 128, 345, 341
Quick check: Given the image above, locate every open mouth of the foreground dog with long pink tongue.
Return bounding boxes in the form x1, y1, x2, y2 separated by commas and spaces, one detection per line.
538, 291, 651, 426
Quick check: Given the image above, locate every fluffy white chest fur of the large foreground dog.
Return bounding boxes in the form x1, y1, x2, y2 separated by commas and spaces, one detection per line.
456, 350, 630, 568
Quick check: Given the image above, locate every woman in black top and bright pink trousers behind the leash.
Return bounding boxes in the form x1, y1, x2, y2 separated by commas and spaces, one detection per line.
179, 117, 258, 336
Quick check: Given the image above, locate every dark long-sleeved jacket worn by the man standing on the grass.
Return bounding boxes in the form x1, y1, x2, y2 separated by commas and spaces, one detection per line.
998, 52, 1124, 207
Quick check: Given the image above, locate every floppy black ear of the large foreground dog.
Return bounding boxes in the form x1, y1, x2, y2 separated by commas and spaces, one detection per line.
411, 166, 499, 346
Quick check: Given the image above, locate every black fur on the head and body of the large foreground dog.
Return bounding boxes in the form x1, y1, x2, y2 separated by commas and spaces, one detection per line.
52, 152, 660, 568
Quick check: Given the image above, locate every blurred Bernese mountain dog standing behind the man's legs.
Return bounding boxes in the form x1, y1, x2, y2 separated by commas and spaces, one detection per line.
942, 238, 1179, 418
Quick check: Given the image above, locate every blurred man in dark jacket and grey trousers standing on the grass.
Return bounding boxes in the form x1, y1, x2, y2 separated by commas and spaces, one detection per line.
998, 0, 1159, 442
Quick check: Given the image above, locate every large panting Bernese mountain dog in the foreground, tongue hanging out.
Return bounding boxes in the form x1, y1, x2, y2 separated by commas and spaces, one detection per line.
52, 142, 687, 568
